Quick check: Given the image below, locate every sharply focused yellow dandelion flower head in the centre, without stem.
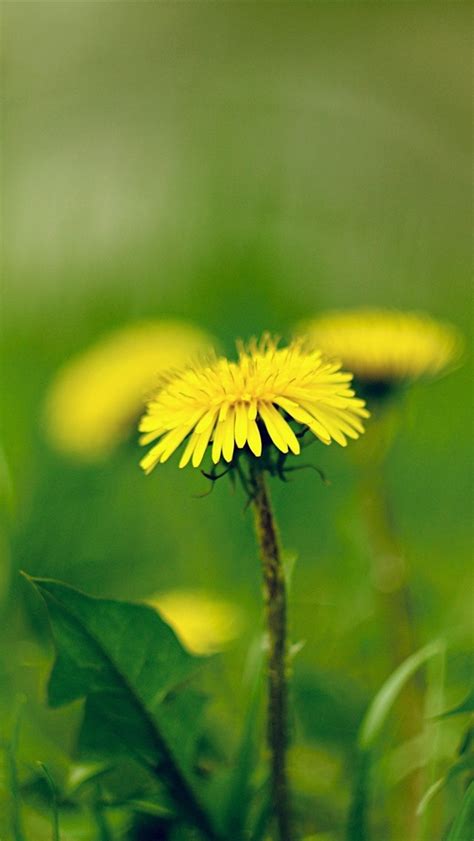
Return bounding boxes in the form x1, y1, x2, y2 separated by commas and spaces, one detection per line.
139, 336, 369, 473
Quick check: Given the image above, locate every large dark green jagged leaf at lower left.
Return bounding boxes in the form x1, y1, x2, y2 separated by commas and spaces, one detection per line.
26, 576, 225, 839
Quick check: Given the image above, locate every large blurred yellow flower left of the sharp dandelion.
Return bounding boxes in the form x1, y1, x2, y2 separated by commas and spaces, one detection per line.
45, 320, 210, 461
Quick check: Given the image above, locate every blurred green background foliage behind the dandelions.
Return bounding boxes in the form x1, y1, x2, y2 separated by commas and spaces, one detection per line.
0, 0, 473, 841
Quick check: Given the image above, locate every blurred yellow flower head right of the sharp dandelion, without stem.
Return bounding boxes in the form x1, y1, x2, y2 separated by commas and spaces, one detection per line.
301, 309, 461, 386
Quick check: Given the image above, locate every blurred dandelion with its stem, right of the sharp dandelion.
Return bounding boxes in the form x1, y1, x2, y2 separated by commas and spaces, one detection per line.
302, 308, 462, 837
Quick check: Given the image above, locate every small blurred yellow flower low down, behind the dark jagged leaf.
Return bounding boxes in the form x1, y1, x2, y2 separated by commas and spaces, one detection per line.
149, 590, 244, 654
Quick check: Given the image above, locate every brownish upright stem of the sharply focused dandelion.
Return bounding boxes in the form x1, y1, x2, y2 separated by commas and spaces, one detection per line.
251, 468, 291, 841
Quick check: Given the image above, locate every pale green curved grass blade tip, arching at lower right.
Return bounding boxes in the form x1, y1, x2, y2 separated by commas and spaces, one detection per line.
358, 641, 444, 750
